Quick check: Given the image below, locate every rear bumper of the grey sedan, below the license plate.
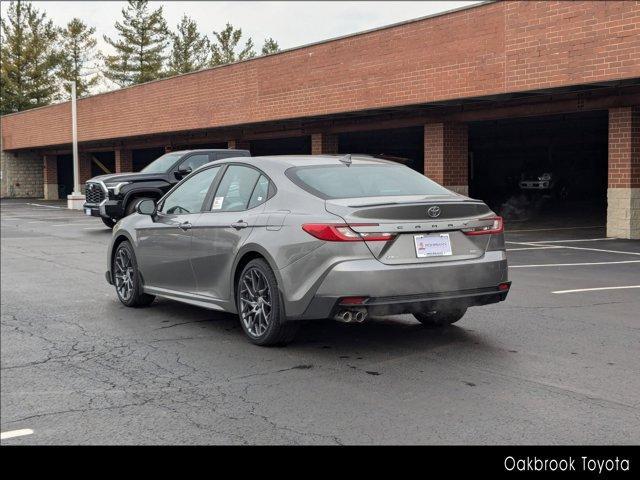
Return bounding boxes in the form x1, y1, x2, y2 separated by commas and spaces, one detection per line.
287, 250, 508, 319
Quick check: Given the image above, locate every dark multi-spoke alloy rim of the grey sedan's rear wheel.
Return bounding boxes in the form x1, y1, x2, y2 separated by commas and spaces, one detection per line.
240, 268, 271, 337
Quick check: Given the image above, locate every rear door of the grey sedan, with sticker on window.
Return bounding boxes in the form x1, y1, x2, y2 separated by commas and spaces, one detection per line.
191, 164, 274, 302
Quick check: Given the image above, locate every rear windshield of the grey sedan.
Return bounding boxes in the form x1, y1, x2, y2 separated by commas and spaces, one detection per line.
286, 164, 451, 199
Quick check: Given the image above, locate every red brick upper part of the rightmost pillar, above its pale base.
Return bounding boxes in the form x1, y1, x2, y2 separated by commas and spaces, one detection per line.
609, 106, 640, 188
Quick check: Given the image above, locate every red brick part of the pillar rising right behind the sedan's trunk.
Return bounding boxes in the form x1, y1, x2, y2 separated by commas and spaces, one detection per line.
424, 123, 469, 186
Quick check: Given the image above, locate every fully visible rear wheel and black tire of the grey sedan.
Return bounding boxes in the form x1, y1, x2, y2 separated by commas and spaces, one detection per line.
236, 258, 298, 346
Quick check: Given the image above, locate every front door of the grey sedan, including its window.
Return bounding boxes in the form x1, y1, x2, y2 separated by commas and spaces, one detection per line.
137, 167, 220, 293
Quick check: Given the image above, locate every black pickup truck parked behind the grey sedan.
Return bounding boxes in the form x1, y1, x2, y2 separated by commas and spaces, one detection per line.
83, 149, 251, 228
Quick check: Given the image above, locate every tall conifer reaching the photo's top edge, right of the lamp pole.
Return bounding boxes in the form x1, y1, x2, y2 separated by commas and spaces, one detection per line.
103, 0, 169, 87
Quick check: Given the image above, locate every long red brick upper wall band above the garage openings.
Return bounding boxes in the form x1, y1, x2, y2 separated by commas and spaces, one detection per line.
2, 1, 640, 150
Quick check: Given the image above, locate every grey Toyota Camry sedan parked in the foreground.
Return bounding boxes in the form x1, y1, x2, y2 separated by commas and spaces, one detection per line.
106, 155, 510, 345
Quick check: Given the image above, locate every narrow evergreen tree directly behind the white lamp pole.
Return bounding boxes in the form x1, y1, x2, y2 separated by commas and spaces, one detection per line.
58, 18, 99, 97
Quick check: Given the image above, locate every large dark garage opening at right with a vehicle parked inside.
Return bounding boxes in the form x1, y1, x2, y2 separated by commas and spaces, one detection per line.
469, 111, 608, 224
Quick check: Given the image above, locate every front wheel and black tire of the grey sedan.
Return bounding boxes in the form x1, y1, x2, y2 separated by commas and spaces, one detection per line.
111, 240, 156, 307
